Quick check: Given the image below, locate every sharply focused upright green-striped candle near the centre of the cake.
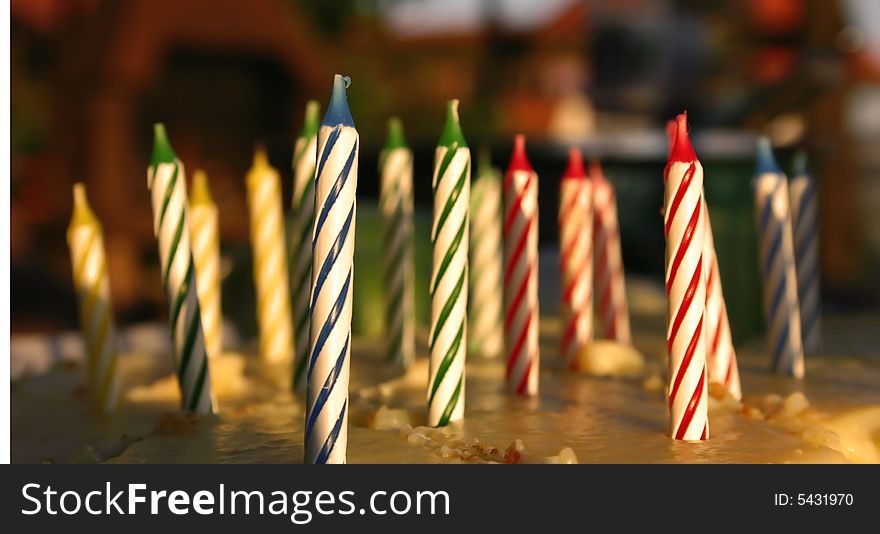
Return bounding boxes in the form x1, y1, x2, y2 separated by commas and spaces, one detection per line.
428, 100, 471, 426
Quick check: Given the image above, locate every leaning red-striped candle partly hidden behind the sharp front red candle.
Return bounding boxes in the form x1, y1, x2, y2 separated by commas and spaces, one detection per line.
703, 202, 742, 400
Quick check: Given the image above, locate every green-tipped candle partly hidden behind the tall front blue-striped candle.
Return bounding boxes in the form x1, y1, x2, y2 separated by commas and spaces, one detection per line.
288, 100, 320, 394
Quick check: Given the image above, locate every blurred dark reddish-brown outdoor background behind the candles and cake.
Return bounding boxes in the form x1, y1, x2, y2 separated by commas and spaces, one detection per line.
10, 0, 880, 348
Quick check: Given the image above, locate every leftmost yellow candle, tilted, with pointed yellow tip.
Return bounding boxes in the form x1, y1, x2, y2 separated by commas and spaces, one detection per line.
67, 183, 119, 413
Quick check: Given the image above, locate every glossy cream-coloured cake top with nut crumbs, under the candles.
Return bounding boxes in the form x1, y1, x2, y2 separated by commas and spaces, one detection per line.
11, 283, 880, 463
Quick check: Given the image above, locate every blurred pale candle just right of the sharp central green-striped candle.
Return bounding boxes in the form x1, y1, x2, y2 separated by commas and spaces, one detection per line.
468, 151, 504, 358
